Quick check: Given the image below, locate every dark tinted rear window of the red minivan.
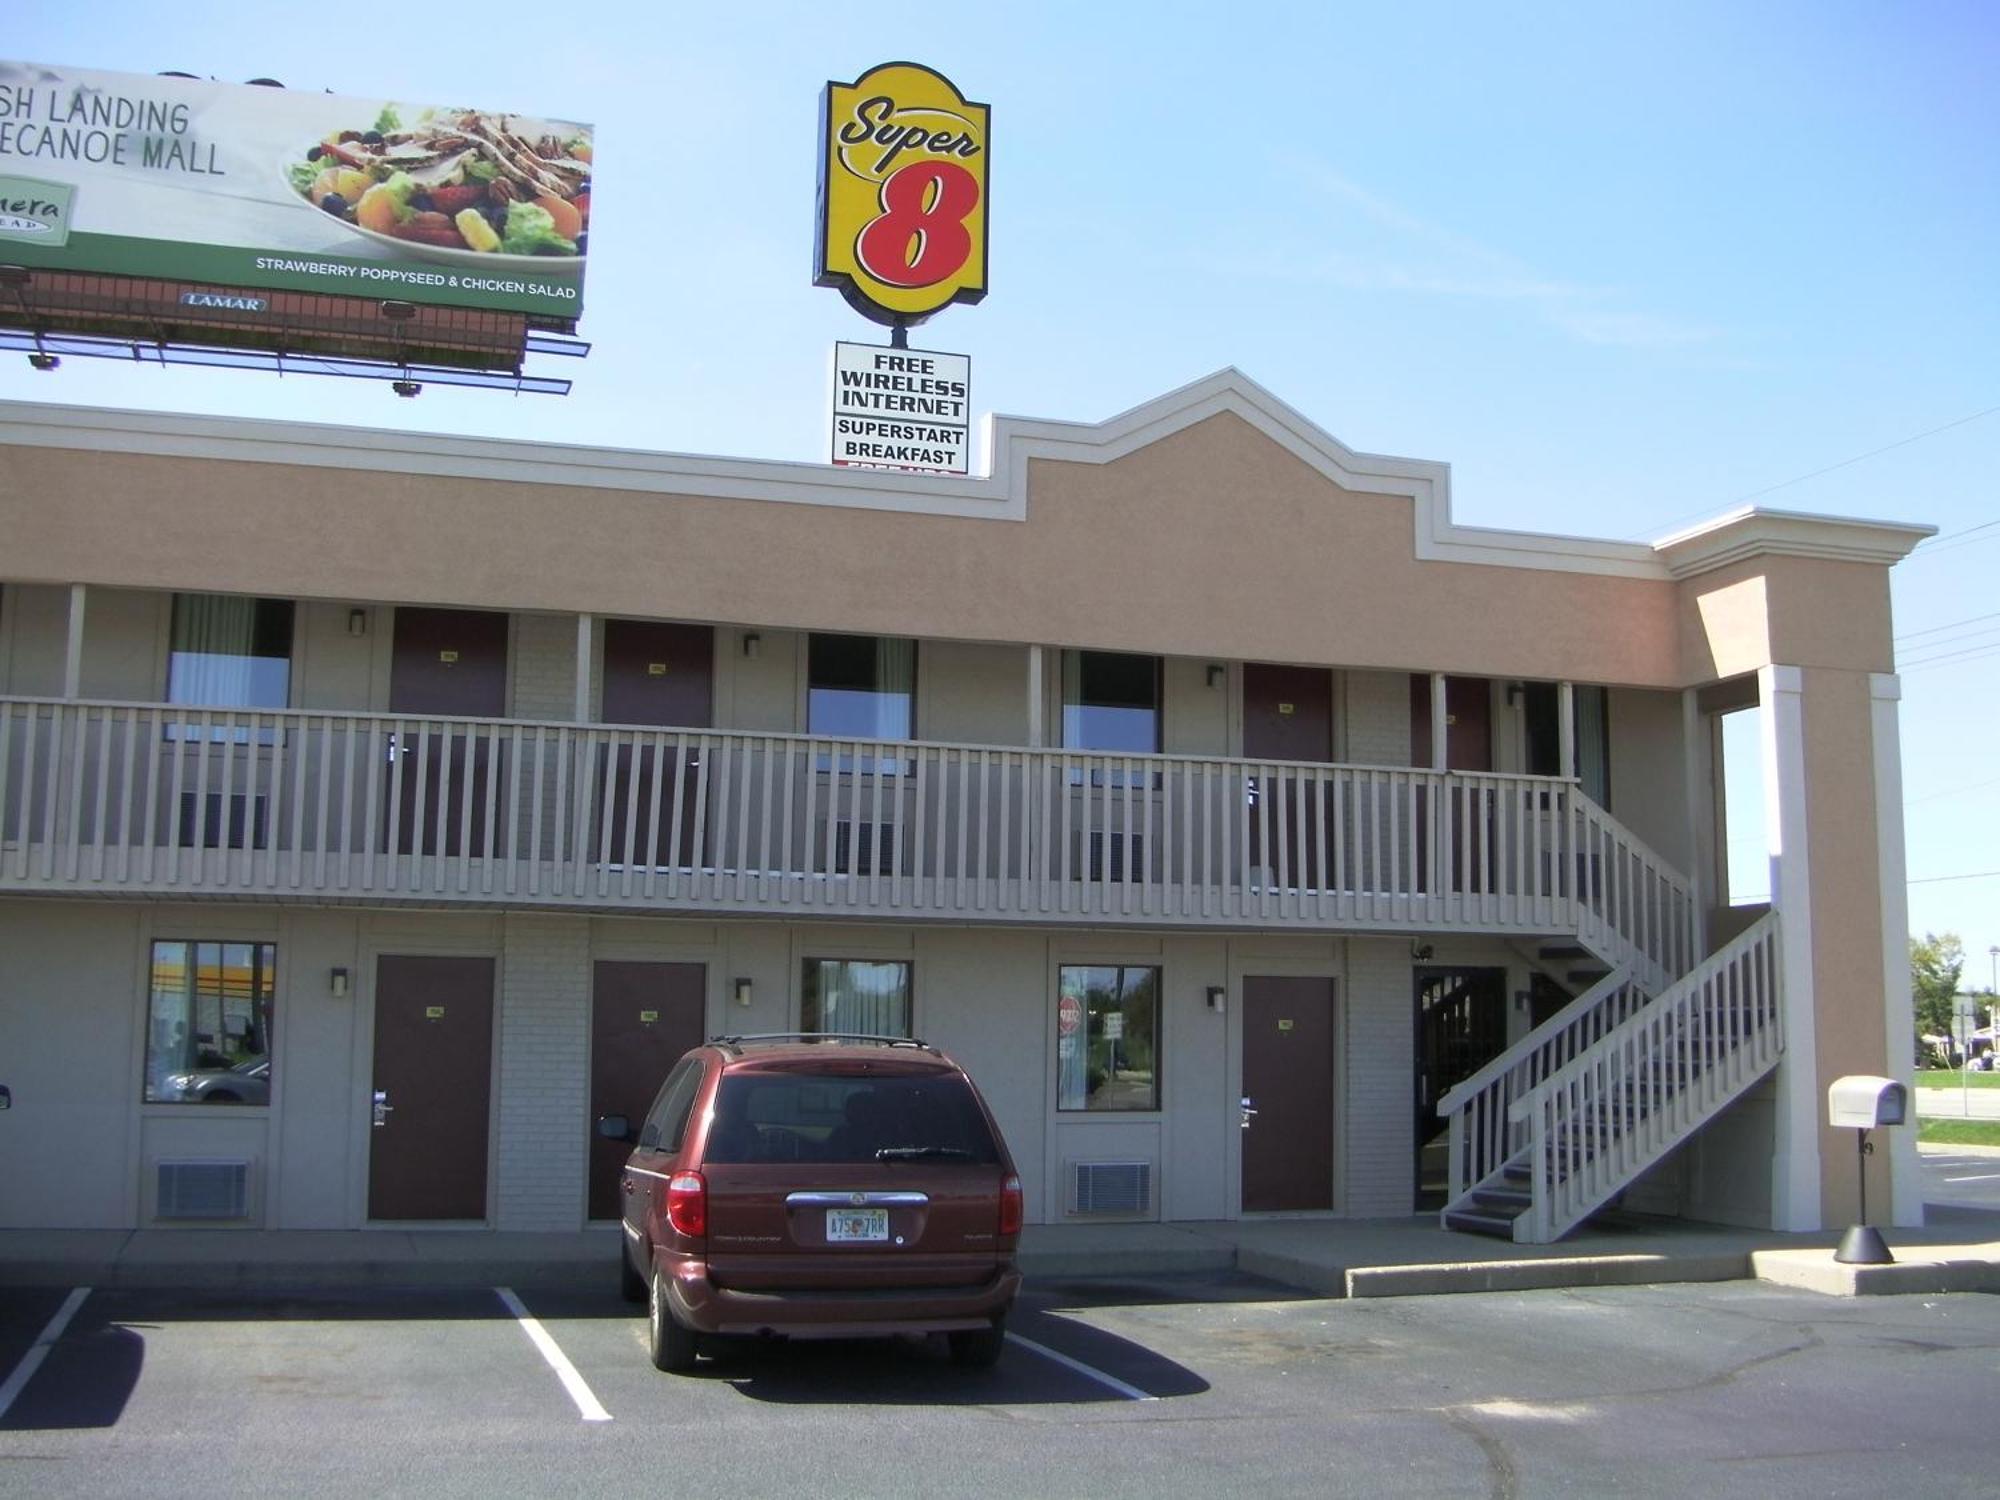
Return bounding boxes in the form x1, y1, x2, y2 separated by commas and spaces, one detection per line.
702, 1072, 1000, 1166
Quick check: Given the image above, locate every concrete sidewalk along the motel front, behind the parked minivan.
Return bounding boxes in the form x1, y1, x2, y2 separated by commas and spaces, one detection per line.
0, 1204, 2000, 1298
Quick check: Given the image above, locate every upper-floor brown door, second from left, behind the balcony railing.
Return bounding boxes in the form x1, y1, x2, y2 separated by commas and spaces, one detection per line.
598, 620, 716, 866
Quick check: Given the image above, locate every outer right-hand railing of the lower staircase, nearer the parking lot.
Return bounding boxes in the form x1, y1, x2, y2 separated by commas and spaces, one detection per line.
1508, 912, 1784, 1244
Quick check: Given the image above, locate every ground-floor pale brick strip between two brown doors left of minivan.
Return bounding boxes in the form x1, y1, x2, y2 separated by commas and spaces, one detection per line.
494, 916, 590, 1230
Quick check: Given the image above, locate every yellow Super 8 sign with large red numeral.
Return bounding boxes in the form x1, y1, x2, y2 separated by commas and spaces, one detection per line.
812, 62, 990, 324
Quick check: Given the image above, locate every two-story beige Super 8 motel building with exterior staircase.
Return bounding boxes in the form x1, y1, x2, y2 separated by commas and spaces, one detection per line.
0, 372, 1926, 1240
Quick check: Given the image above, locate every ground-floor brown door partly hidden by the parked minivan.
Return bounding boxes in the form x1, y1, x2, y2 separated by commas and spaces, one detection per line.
590, 960, 708, 1218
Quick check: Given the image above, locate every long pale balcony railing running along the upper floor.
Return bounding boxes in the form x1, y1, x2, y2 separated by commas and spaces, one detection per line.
0, 698, 1688, 964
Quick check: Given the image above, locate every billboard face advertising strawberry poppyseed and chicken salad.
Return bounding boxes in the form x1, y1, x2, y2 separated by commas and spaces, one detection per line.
0, 62, 592, 324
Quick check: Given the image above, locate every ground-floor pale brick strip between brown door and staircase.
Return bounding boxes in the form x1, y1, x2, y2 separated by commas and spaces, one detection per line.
1342, 938, 1416, 1218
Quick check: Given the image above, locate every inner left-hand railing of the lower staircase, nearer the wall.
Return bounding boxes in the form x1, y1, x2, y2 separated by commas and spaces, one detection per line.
1438, 964, 1652, 1212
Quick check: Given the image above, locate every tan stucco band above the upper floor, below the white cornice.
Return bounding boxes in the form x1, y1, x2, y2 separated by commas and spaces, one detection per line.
0, 414, 1720, 682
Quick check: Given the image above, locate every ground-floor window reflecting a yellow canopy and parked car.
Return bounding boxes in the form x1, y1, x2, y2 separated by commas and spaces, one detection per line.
146, 940, 278, 1104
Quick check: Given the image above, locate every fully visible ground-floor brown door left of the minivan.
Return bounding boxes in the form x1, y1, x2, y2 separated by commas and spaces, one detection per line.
368, 954, 494, 1218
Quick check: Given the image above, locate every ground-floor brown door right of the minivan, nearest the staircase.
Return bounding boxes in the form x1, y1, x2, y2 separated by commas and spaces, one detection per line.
1242, 976, 1334, 1214
